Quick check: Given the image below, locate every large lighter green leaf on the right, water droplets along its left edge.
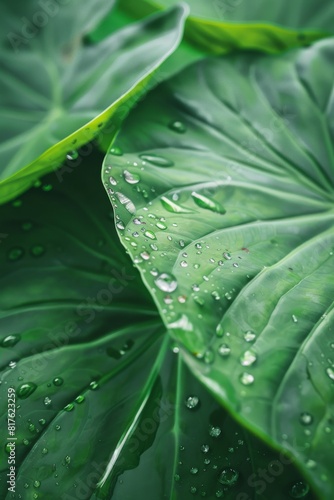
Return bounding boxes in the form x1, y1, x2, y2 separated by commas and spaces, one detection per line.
103, 40, 334, 498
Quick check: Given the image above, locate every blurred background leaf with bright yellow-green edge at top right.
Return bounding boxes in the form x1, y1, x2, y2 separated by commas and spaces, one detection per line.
120, 0, 334, 54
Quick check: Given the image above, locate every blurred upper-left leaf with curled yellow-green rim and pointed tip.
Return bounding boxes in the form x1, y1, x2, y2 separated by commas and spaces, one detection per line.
0, 1, 185, 202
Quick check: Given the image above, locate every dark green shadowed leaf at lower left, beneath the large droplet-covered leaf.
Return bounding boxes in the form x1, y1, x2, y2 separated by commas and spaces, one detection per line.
0, 148, 313, 500
